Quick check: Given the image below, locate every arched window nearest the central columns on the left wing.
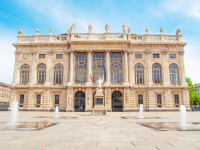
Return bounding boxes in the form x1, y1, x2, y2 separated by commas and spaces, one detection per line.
54, 64, 63, 84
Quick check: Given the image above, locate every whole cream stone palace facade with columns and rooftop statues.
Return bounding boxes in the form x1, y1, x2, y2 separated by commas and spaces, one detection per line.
9, 24, 190, 111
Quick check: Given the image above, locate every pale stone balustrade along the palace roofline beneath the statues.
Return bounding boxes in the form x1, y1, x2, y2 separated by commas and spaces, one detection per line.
18, 33, 181, 43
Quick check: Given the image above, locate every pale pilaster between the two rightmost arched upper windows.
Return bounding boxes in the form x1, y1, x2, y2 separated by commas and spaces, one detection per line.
162, 50, 170, 86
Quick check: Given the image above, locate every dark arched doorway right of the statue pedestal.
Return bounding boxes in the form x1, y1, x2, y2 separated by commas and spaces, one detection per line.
112, 91, 122, 112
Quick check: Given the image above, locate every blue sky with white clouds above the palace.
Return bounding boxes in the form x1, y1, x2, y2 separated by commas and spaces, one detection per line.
0, 0, 200, 84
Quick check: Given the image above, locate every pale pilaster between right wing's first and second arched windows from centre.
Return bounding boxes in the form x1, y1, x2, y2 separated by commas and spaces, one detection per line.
146, 50, 153, 86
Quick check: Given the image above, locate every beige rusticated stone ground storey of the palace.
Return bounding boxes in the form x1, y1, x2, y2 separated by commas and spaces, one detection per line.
8, 87, 190, 112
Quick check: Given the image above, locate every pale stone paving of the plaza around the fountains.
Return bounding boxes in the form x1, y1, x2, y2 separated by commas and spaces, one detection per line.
0, 111, 200, 150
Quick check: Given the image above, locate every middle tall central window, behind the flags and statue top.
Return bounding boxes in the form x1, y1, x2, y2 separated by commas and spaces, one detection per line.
93, 53, 106, 82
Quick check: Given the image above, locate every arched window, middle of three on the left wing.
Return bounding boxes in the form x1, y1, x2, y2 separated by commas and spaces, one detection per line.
37, 64, 46, 83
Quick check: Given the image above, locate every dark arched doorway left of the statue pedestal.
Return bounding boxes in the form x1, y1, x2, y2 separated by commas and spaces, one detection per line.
74, 91, 85, 112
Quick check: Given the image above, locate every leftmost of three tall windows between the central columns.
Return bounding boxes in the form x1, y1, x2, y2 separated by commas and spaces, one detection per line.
75, 53, 87, 83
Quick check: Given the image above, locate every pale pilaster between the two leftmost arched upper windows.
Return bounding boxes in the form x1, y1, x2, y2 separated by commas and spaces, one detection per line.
30, 52, 37, 86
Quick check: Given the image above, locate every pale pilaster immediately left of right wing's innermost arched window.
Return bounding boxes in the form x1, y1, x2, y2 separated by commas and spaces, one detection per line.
129, 51, 135, 86
